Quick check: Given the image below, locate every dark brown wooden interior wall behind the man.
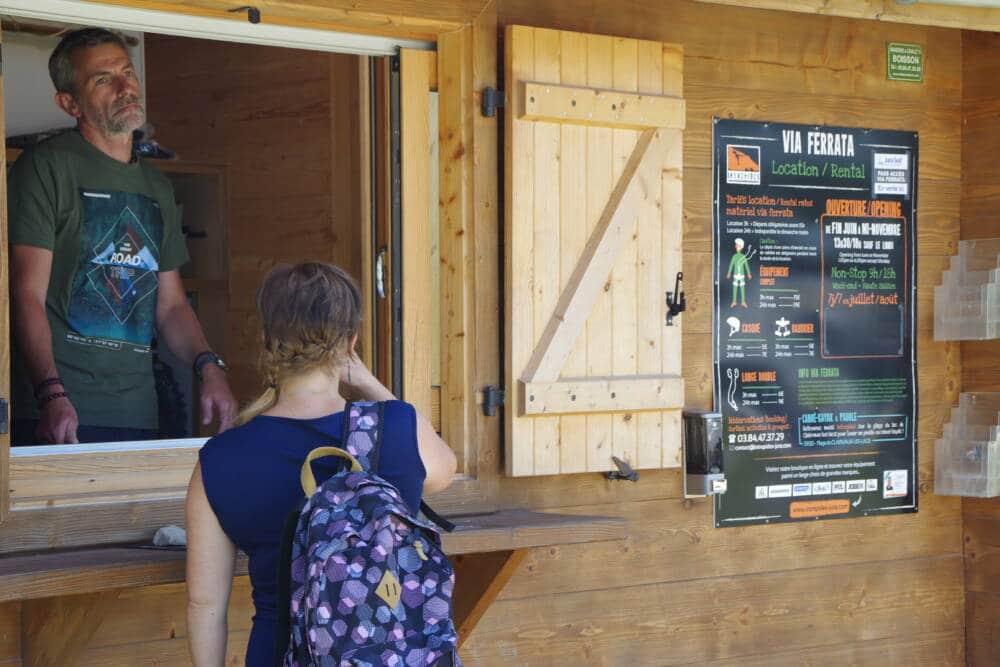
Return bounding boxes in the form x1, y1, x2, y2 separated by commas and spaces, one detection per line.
146, 36, 362, 401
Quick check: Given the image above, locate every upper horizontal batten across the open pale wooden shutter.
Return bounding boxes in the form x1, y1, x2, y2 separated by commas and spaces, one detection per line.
521, 81, 685, 130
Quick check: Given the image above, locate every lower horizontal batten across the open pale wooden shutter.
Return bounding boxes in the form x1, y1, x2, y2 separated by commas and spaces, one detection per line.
523, 375, 684, 418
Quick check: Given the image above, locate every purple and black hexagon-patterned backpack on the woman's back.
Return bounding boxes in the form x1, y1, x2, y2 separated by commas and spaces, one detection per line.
276, 402, 461, 667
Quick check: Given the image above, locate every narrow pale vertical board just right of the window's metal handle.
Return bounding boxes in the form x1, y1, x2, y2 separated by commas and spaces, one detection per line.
400, 49, 434, 415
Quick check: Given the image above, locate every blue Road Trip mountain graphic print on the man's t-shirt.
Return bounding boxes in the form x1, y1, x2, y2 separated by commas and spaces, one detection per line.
69, 189, 163, 346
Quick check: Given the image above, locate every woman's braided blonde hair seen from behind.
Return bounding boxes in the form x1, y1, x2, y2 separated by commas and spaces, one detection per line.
236, 262, 361, 425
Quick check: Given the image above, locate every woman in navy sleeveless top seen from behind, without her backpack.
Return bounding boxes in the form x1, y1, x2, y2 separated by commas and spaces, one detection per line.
187, 262, 456, 667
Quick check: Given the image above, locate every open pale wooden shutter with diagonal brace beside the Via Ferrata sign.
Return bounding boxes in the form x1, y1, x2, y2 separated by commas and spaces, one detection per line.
505, 26, 685, 476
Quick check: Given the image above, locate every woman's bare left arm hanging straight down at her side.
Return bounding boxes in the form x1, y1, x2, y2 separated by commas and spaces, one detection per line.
187, 463, 236, 667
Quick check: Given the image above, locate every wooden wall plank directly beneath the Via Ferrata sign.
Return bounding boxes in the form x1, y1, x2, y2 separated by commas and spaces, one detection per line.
501, 494, 962, 599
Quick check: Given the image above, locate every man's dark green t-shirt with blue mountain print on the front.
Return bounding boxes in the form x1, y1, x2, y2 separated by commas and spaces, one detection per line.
8, 131, 188, 429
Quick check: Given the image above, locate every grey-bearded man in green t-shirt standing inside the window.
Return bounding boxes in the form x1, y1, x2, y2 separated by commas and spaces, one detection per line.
8, 28, 236, 444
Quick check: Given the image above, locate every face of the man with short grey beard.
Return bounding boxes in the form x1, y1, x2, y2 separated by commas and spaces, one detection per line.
64, 44, 146, 136
